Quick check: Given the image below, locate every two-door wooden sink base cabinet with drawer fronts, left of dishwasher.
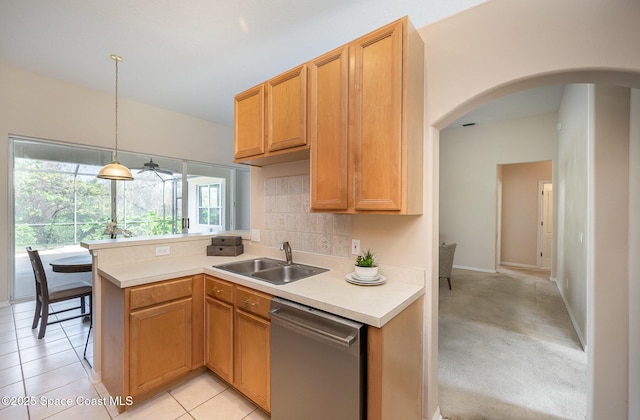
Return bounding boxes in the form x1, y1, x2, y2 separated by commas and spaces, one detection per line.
205, 275, 272, 412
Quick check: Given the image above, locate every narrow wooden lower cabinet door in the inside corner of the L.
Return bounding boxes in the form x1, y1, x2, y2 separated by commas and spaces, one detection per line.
205, 297, 233, 383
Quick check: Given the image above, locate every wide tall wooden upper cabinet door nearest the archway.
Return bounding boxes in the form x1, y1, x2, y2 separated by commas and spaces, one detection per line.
351, 21, 404, 210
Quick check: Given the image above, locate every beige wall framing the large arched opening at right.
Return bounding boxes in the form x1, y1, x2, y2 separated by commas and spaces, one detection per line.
420, 0, 640, 418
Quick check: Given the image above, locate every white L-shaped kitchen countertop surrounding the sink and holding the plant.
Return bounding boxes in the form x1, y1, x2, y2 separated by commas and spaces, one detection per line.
98, 254, 424, 327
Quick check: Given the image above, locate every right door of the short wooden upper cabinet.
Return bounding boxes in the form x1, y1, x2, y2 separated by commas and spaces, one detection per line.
266, 65, 307, 152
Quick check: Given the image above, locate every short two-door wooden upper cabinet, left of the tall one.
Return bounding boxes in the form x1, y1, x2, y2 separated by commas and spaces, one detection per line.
234, 65, 309, 166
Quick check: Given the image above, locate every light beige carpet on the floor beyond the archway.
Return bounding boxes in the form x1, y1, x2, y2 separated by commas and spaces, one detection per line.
439, 269, 587, 420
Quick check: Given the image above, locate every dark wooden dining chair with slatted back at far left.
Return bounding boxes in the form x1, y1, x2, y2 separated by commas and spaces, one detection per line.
27, 247, 93, 340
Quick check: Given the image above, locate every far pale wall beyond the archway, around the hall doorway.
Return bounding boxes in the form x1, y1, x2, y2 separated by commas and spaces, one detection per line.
439, 113, 558, 271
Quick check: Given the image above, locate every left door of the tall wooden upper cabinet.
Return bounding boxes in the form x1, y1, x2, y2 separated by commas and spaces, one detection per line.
308, 46, 349, 210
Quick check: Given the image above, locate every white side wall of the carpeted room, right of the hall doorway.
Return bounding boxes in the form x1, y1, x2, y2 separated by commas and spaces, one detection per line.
554, 84, 593, 346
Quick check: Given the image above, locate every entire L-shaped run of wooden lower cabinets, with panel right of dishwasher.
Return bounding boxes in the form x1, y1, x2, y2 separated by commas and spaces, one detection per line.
101, 275, 423, 420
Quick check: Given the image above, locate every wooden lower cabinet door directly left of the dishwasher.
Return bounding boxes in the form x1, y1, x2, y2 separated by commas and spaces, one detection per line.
234, 310, 271, 411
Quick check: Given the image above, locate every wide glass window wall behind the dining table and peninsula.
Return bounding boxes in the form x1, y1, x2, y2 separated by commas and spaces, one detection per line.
8, 137, 250, 301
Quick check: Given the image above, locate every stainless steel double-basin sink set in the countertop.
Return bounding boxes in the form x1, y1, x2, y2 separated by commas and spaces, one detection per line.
214, 258, 328, 284
